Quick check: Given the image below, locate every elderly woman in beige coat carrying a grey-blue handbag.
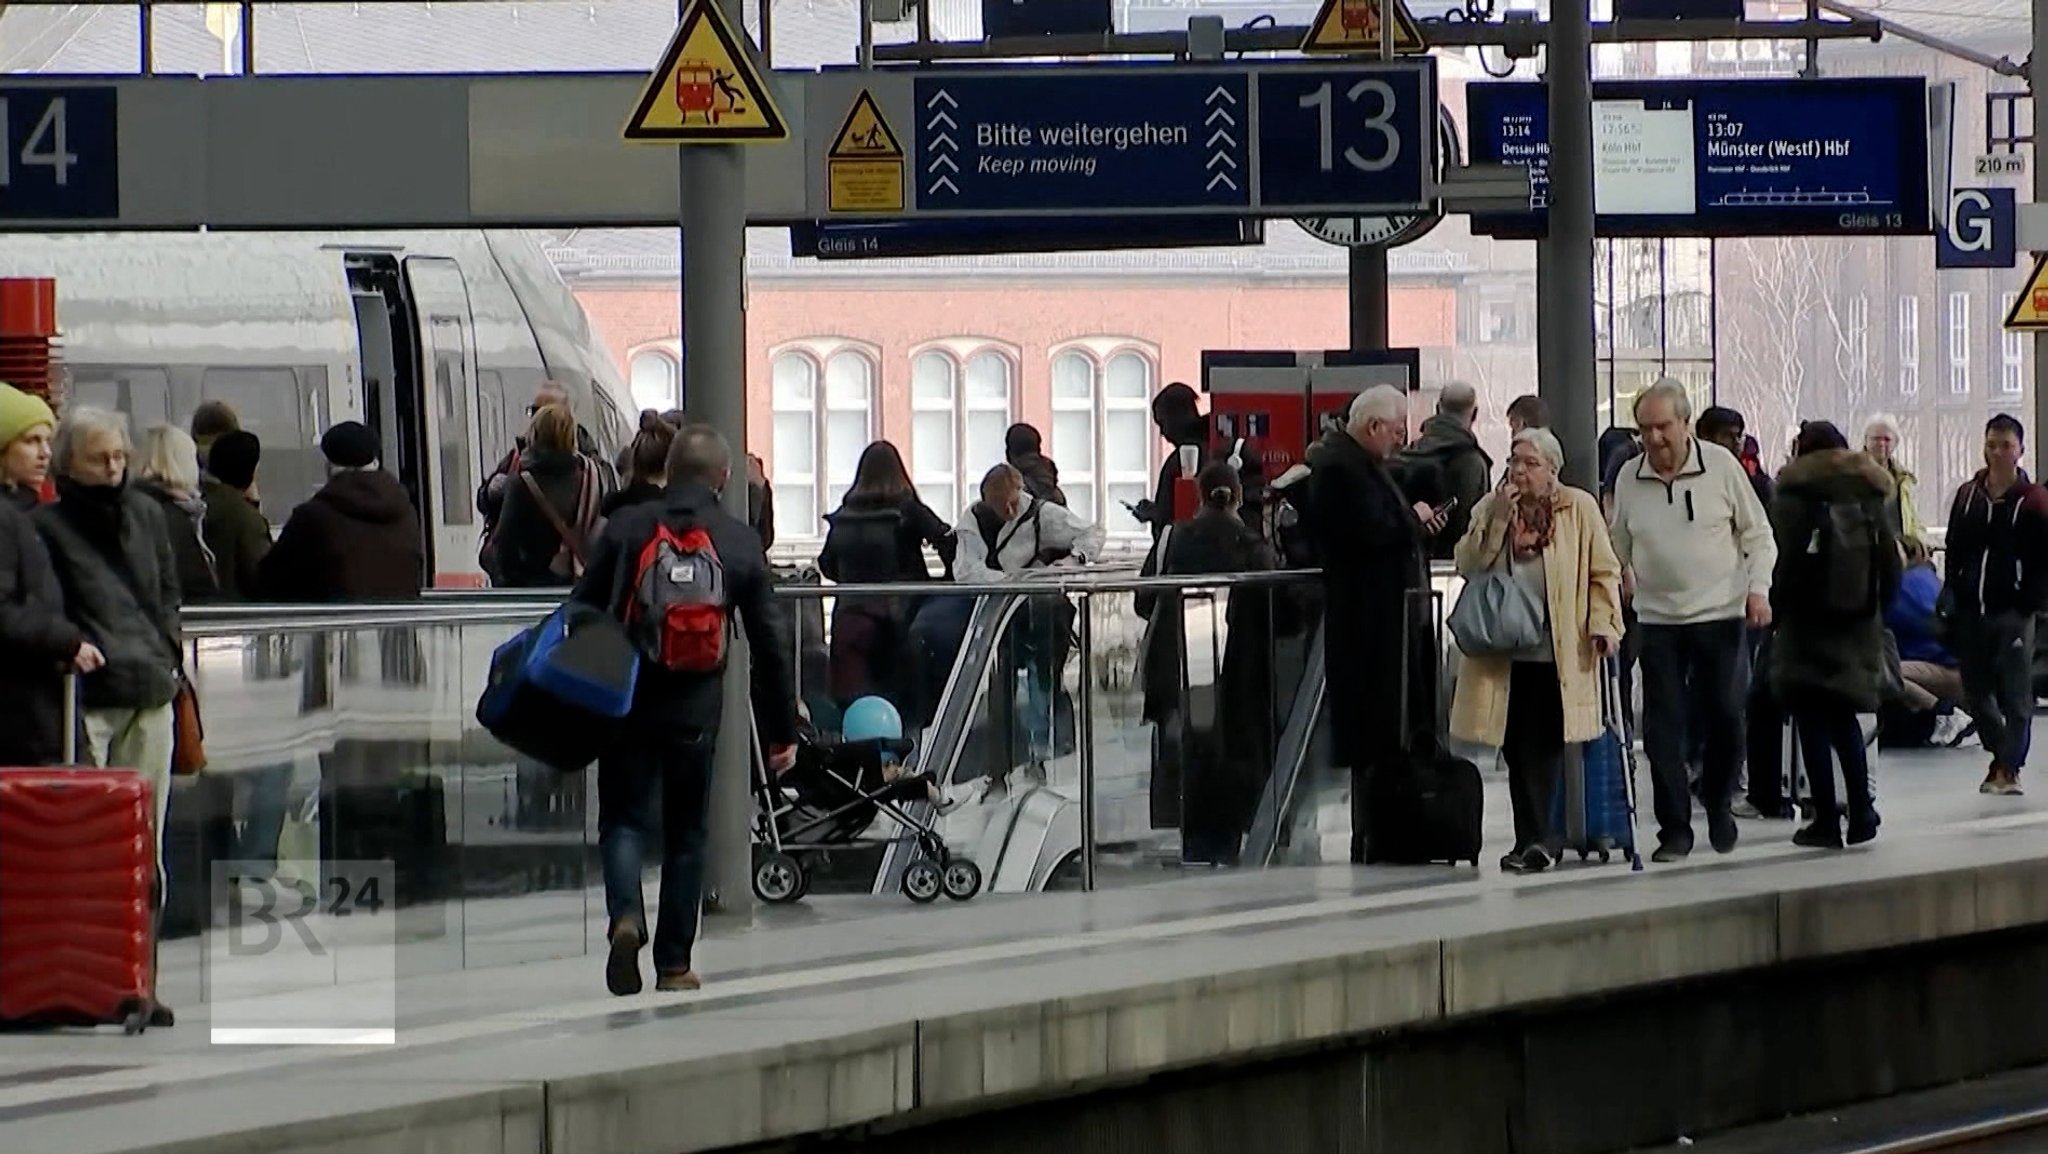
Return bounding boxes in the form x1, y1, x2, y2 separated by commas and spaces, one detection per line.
1450, 428, 1622, 873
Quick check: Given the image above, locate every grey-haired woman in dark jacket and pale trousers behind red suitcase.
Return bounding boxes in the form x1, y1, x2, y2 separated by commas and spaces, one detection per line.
35, 406, 182, 1025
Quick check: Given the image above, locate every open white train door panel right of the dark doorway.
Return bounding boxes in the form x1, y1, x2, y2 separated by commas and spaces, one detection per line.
403, 256, 496, 586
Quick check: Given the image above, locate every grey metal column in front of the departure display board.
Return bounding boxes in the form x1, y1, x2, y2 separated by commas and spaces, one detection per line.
1536, 0, 1597, 490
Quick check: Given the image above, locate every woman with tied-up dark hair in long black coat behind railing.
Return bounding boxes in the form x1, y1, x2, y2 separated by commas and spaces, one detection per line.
1137, 461, 1284, 865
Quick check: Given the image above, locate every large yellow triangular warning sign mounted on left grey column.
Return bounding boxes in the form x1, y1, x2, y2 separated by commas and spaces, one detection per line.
621, 0, 788, 143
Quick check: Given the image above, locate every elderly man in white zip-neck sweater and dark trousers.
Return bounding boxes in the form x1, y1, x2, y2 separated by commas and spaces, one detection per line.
1614, 377, 1778, 861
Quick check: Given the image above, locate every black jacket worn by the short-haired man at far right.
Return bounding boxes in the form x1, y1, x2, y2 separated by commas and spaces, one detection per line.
1933, 469, 2048, 617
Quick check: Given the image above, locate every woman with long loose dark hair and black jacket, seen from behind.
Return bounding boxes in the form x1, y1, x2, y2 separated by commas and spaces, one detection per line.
817, 441, 954, 713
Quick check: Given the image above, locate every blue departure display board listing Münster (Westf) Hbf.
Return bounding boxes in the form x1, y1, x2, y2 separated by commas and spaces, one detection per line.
1466, 78, 1933, 236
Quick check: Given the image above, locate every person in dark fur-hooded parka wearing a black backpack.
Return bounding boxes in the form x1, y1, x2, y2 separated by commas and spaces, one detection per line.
1751, 420, 1901, 849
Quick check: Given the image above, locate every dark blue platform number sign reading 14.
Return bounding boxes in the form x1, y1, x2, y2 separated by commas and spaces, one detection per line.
0, 84, 121, 228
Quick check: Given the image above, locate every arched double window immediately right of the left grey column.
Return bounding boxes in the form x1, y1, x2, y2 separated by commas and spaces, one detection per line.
770, 348, 874, 537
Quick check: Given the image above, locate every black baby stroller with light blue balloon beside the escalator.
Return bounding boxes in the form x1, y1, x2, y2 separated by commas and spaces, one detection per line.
754, 697, 981, 904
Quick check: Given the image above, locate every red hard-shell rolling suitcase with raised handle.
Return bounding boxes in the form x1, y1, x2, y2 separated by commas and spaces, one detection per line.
0, 676, 156, 1033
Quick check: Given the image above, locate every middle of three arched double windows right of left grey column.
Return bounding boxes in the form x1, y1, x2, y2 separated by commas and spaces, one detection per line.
909, 348, 1012, 521
